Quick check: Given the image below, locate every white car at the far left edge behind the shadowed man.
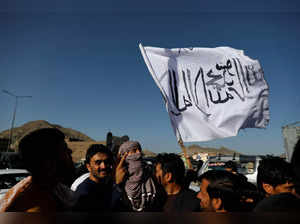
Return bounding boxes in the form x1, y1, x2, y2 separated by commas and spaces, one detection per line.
0, 169, 30, 199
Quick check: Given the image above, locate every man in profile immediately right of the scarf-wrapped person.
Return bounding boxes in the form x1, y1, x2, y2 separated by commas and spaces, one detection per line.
155, 153, 200, 212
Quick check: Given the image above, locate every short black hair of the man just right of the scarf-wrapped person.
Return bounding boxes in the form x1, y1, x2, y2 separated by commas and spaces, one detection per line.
155, 153, 185, 185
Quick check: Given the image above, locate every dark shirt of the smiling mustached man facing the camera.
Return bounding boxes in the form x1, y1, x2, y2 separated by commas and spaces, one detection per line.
74, 178, 113, 212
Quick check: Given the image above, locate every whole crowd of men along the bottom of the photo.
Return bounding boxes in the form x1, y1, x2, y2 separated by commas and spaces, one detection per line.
0, 128, 300, 213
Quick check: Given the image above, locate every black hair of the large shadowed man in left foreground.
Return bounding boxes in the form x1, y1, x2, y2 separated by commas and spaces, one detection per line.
19, 128, 65, 173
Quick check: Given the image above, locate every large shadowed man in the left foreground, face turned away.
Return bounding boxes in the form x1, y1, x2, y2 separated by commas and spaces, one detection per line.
0, 128, 76, 212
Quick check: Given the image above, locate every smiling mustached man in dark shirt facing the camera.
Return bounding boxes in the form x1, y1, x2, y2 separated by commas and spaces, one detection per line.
74, 144, 114, 212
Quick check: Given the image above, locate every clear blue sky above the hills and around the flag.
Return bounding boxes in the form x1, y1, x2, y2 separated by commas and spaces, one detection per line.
0, 0, 300, 154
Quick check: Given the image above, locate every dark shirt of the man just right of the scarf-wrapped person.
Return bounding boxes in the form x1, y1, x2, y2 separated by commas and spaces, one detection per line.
163, 189, 200, 212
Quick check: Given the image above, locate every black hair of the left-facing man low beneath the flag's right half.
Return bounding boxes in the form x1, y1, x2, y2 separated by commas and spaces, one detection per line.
199, 170, 242, 212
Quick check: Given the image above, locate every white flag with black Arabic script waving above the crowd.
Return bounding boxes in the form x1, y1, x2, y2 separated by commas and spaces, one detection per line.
140, 44, 269, 142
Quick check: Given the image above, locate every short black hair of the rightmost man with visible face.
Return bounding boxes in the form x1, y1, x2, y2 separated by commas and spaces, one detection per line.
257, 155, 294, 194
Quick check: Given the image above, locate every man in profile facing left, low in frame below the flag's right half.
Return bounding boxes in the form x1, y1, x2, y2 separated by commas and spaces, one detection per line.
197, 170, 242, 212
